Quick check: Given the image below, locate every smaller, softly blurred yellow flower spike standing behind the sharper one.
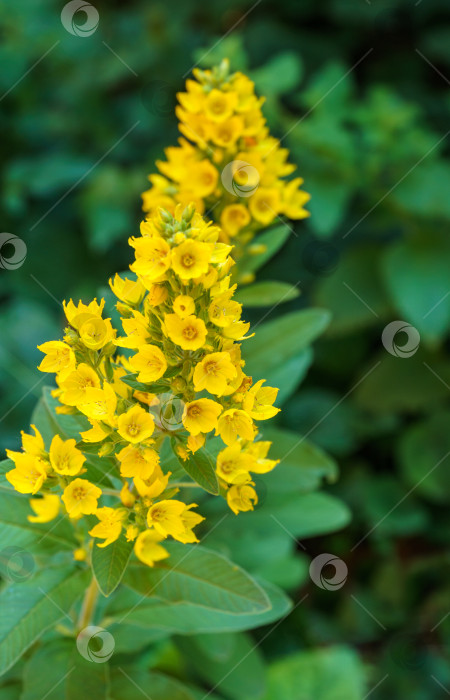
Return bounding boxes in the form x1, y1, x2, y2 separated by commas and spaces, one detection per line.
142, 61, 310, 270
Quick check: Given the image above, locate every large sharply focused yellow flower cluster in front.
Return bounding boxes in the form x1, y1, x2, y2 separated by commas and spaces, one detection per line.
6, 204, 279, 566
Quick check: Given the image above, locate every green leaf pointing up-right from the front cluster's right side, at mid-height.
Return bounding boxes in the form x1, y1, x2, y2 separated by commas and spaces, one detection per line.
242, 309, 330, 401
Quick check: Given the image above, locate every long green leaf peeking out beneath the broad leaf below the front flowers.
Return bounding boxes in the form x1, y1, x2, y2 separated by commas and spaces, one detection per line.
105, 581, 292, 635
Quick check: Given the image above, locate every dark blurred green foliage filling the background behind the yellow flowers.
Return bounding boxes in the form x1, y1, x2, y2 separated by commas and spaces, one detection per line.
0, 0, 450, 700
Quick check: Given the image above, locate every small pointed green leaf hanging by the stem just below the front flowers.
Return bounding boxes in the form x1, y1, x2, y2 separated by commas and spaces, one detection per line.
92, 535, 133, 596
